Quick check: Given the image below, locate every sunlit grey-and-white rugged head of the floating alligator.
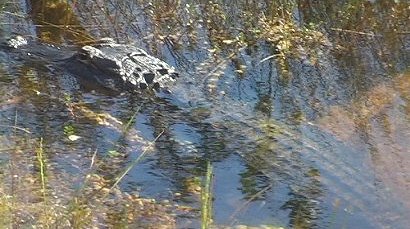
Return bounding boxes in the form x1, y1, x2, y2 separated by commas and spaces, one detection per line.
74, 38, 178, 89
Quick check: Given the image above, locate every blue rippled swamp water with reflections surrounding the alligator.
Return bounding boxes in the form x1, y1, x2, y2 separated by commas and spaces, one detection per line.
0, 1, 410, 228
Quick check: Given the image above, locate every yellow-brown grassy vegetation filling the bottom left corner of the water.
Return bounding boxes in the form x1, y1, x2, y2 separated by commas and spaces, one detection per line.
0, 107, 179, 228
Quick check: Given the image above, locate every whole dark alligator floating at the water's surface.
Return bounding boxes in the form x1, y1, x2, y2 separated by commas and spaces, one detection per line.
2, 36, 179, 90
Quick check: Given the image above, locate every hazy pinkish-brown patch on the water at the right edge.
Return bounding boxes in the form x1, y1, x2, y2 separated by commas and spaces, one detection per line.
320, 74, 410, 209
